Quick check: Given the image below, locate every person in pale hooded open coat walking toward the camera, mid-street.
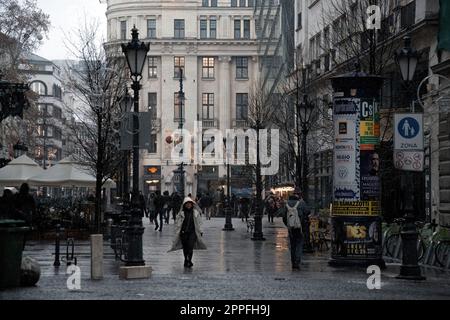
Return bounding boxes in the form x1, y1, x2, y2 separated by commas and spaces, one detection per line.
169, 197, 206, 268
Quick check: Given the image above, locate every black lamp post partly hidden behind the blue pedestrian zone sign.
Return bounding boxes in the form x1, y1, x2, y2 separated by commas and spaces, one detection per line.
395, 36, 425, 280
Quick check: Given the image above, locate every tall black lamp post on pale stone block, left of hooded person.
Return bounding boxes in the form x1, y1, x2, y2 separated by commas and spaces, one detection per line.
122, 26, 150, 266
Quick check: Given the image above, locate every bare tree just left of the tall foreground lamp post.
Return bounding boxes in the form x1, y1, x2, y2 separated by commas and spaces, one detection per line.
62, 22, 126, 231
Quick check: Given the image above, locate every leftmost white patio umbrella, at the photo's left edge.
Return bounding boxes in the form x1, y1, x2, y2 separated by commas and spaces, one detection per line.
0, 155, 44, 187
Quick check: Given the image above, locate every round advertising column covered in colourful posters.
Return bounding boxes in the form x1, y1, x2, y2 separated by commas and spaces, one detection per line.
330, 73, 384, 267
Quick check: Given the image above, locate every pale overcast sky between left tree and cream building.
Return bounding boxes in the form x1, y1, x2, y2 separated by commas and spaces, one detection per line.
36, 0, 106, 60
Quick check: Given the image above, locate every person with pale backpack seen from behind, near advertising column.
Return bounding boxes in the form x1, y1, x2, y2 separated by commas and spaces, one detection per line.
278, 195, 306, 270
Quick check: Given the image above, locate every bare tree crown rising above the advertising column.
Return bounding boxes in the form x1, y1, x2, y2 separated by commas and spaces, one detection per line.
313, 0, 398, 75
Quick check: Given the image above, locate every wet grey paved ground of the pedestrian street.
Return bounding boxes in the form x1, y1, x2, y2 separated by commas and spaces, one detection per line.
0, 217, 450, 300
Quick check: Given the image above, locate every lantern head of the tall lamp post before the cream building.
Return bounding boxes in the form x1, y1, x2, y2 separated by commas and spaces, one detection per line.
122, 26, 150, 80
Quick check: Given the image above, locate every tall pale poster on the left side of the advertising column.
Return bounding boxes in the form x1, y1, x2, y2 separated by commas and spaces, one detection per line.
334, 114, 359, 201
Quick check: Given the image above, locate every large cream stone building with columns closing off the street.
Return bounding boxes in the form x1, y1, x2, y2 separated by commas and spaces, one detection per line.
106, 0, 259, 195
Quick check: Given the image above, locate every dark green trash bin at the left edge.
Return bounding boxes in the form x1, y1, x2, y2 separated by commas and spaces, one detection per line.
0, 220, 30, 288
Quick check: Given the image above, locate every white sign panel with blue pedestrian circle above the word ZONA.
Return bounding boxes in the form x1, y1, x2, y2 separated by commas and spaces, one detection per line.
394, 113, 423, 151
